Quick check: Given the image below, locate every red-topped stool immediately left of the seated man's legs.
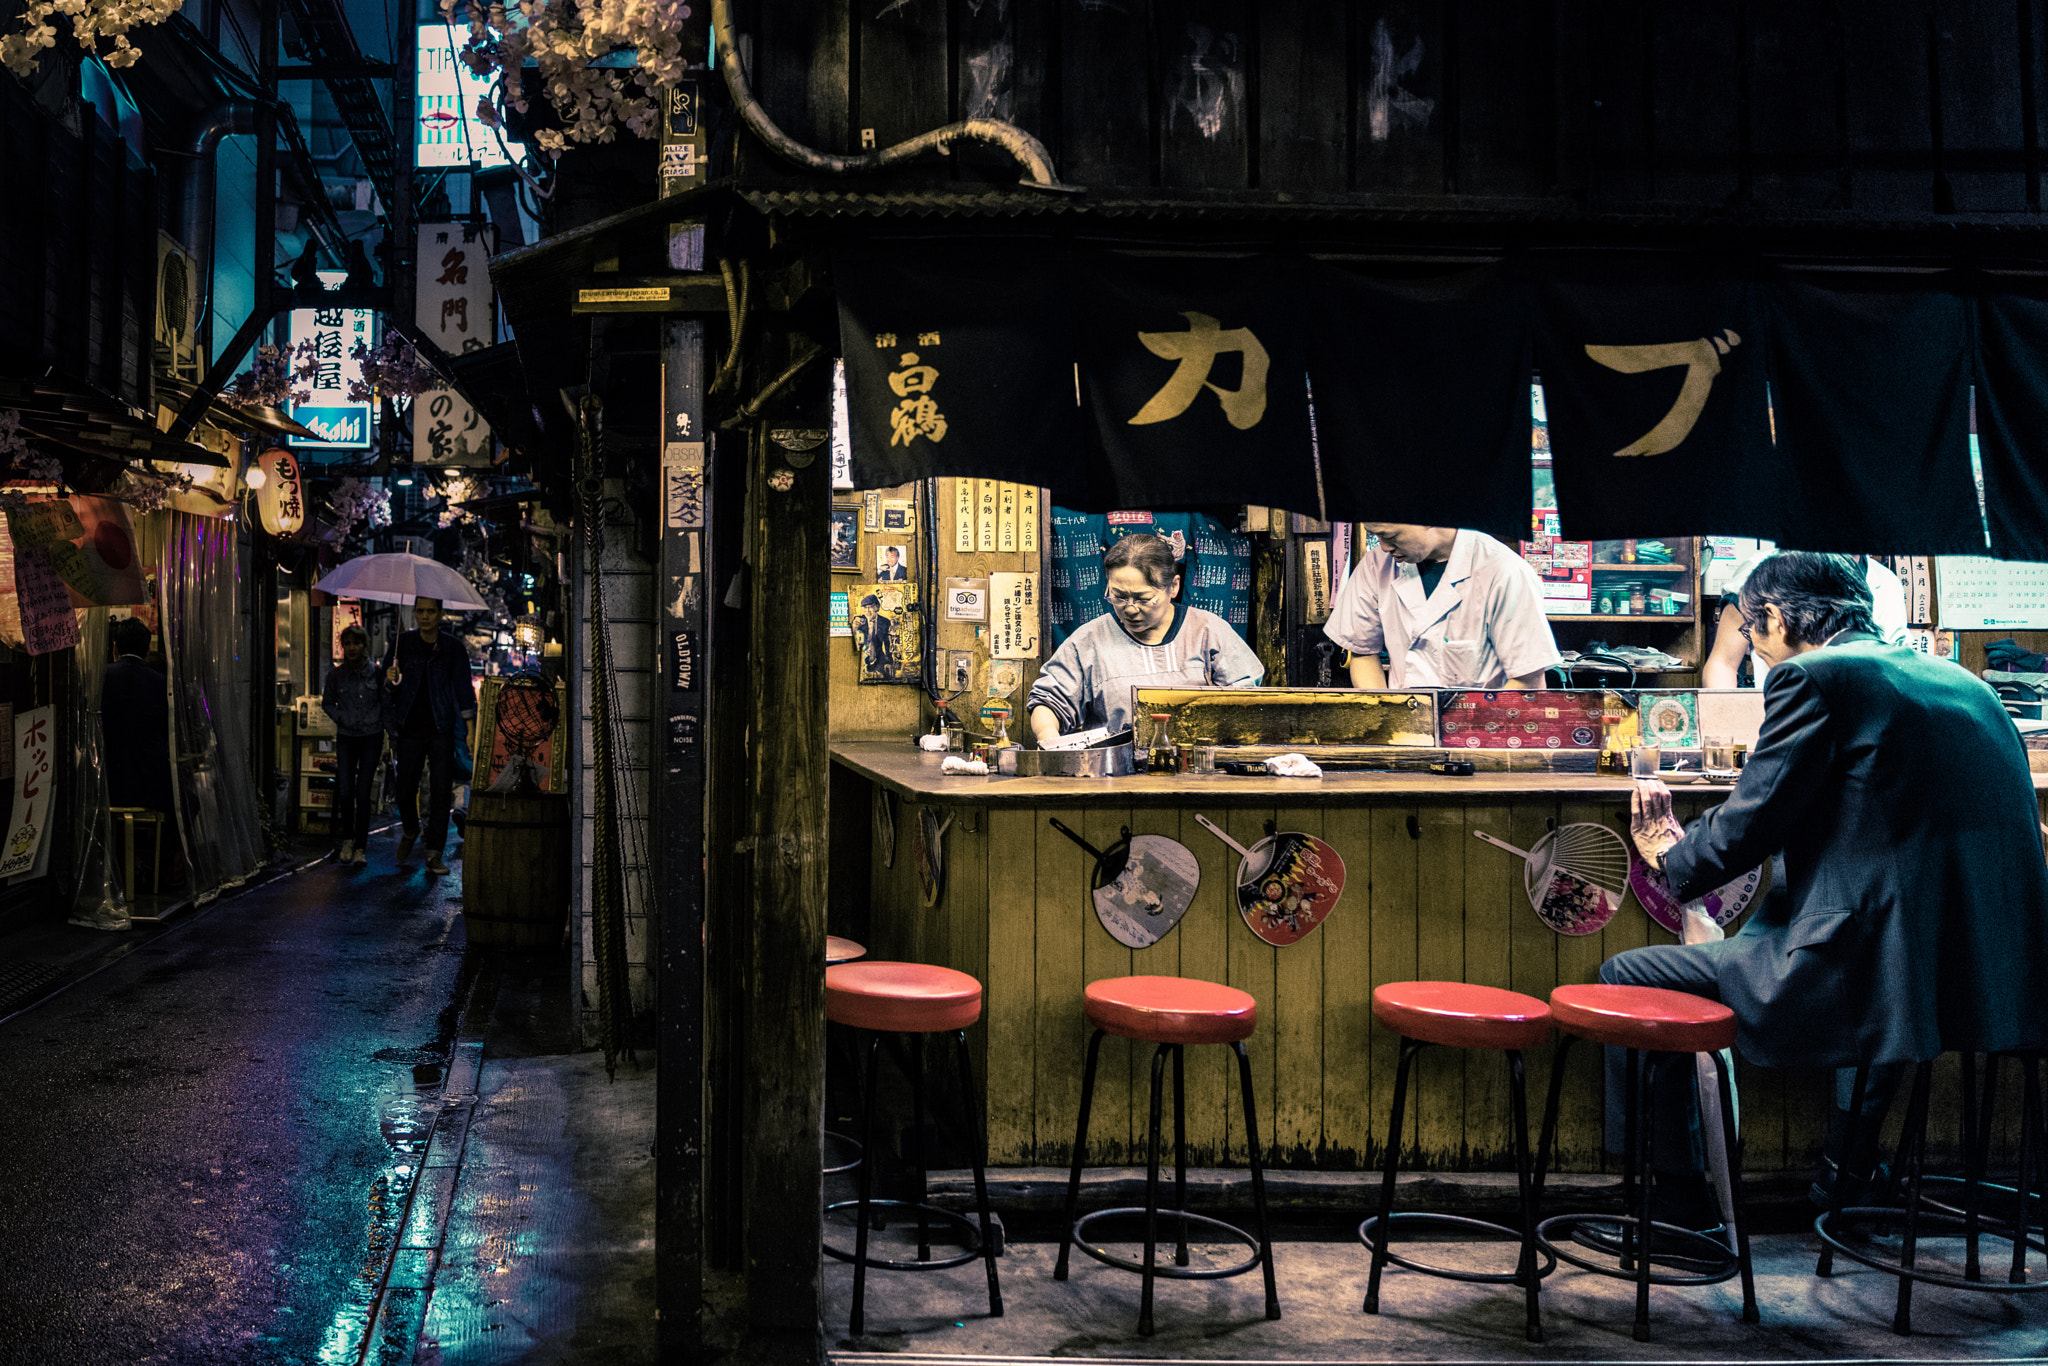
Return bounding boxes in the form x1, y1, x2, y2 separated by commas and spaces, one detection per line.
1536, 983, 1757, 1341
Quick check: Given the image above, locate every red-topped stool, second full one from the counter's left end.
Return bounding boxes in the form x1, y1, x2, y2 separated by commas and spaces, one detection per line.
1053, 977, 1280, 1337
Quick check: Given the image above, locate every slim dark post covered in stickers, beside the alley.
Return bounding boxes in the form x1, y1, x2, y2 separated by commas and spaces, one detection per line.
653, 319, 711, 1362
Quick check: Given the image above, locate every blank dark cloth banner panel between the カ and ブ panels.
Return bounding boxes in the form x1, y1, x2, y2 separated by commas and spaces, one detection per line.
1310, 266, 1530, 545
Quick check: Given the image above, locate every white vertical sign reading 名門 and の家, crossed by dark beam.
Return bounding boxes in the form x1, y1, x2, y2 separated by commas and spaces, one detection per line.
412, 223, 498, 465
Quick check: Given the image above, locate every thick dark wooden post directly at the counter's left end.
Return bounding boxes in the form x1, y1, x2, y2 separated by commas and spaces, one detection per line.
741, 338, 831, 1354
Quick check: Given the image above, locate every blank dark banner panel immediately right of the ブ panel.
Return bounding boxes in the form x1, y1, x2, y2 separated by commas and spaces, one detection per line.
1761, 281, 1985, 555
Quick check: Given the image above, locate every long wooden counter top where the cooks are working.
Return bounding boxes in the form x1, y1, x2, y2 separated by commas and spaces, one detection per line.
831, 739, 1687, 807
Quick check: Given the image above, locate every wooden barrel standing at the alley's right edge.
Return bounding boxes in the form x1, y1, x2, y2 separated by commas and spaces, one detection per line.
463, 793, 569, 948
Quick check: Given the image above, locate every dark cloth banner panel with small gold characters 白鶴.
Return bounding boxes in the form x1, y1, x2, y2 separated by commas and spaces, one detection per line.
831, 246, 1081, 489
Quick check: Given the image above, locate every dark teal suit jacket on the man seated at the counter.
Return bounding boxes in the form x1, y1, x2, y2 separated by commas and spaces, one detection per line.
1665, 633, 2048, 1067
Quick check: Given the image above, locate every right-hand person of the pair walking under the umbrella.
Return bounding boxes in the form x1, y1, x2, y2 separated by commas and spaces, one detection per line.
383, 598, 477, 874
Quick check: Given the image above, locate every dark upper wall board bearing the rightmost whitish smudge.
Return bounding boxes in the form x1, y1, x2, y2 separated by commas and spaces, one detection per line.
1351, 0, 1454, 195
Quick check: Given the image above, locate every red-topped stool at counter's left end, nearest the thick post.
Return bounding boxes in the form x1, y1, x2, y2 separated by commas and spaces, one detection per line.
825, 963, 1004, 1337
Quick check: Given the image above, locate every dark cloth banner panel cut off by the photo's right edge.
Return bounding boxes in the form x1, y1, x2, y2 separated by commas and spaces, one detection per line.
1976, 293, 2048, 561
